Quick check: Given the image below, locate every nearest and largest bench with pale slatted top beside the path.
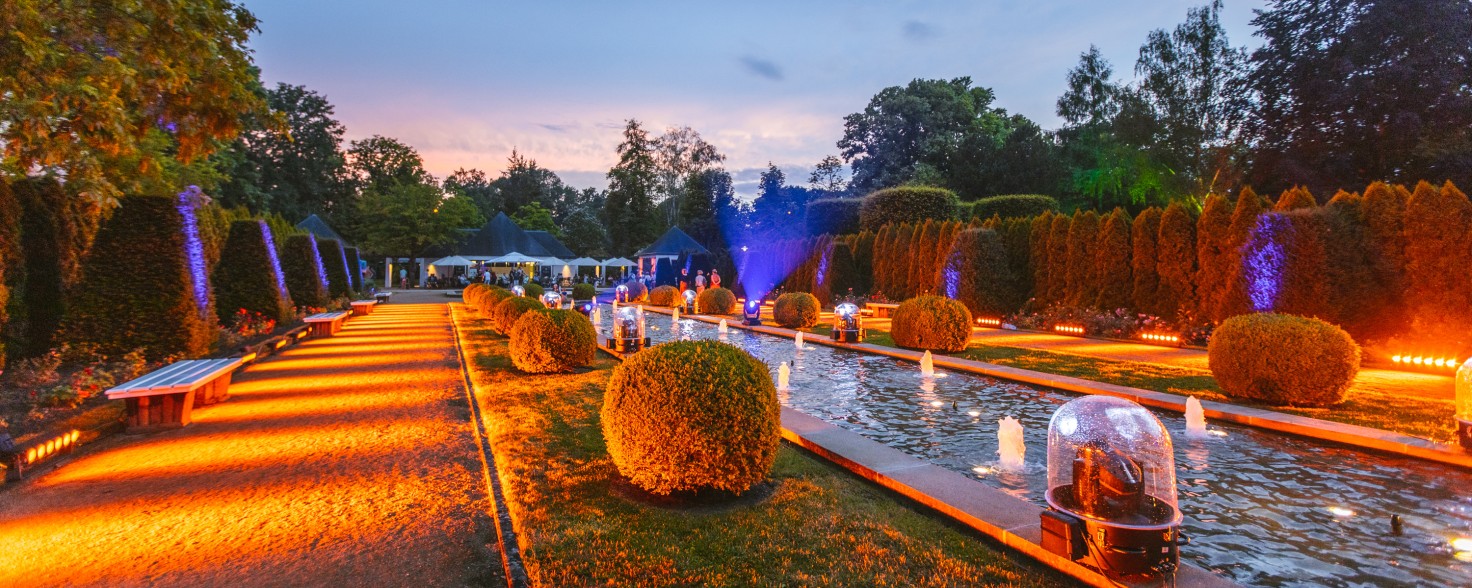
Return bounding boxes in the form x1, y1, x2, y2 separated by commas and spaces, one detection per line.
105, 357, 244, 429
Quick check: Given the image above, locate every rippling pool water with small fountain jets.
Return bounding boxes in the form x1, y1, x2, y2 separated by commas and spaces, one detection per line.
597, 310, 1472, 587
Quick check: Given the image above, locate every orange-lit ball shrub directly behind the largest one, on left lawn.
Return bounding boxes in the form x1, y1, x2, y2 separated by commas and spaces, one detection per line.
506, 308, 598, 374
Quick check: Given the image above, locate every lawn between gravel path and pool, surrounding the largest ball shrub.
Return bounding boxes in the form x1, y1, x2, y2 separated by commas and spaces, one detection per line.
456, 311, 1069, 587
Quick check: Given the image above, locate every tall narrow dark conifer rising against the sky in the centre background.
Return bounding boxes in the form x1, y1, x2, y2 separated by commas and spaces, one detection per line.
604, 118, 659, 255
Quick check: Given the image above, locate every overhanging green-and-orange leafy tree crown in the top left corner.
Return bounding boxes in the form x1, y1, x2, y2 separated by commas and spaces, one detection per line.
0, 0, 266, 200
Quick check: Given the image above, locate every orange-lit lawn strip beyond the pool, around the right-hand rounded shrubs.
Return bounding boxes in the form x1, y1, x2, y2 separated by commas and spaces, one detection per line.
804, 324, 1457, 444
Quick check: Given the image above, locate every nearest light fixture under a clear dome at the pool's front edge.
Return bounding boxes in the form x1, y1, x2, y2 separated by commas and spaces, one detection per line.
1042, 396, 1188, 584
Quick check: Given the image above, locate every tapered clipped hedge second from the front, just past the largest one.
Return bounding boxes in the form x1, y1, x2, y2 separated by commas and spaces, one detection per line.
210, 221, 291, 324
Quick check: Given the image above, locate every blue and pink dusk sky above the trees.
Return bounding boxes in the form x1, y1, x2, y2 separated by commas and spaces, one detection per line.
243, 0, 1264, 197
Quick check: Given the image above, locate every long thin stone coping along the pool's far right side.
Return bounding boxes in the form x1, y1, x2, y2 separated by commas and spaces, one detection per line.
645, 305, 1472, 469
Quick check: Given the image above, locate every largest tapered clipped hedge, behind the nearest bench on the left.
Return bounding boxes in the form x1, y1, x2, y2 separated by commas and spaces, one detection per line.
65, 196, 216, 361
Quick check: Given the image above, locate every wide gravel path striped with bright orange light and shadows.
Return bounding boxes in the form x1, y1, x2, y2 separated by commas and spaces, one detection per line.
0, 293, 503, 587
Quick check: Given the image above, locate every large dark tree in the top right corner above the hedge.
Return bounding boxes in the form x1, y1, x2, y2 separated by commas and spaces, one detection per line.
1248, 0, 1472, 193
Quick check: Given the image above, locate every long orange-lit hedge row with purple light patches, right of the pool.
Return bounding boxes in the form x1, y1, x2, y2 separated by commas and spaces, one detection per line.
746, 183, 1472, 350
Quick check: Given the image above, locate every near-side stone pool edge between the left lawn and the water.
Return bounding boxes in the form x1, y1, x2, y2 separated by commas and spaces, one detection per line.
598, 336, 1238, 588
